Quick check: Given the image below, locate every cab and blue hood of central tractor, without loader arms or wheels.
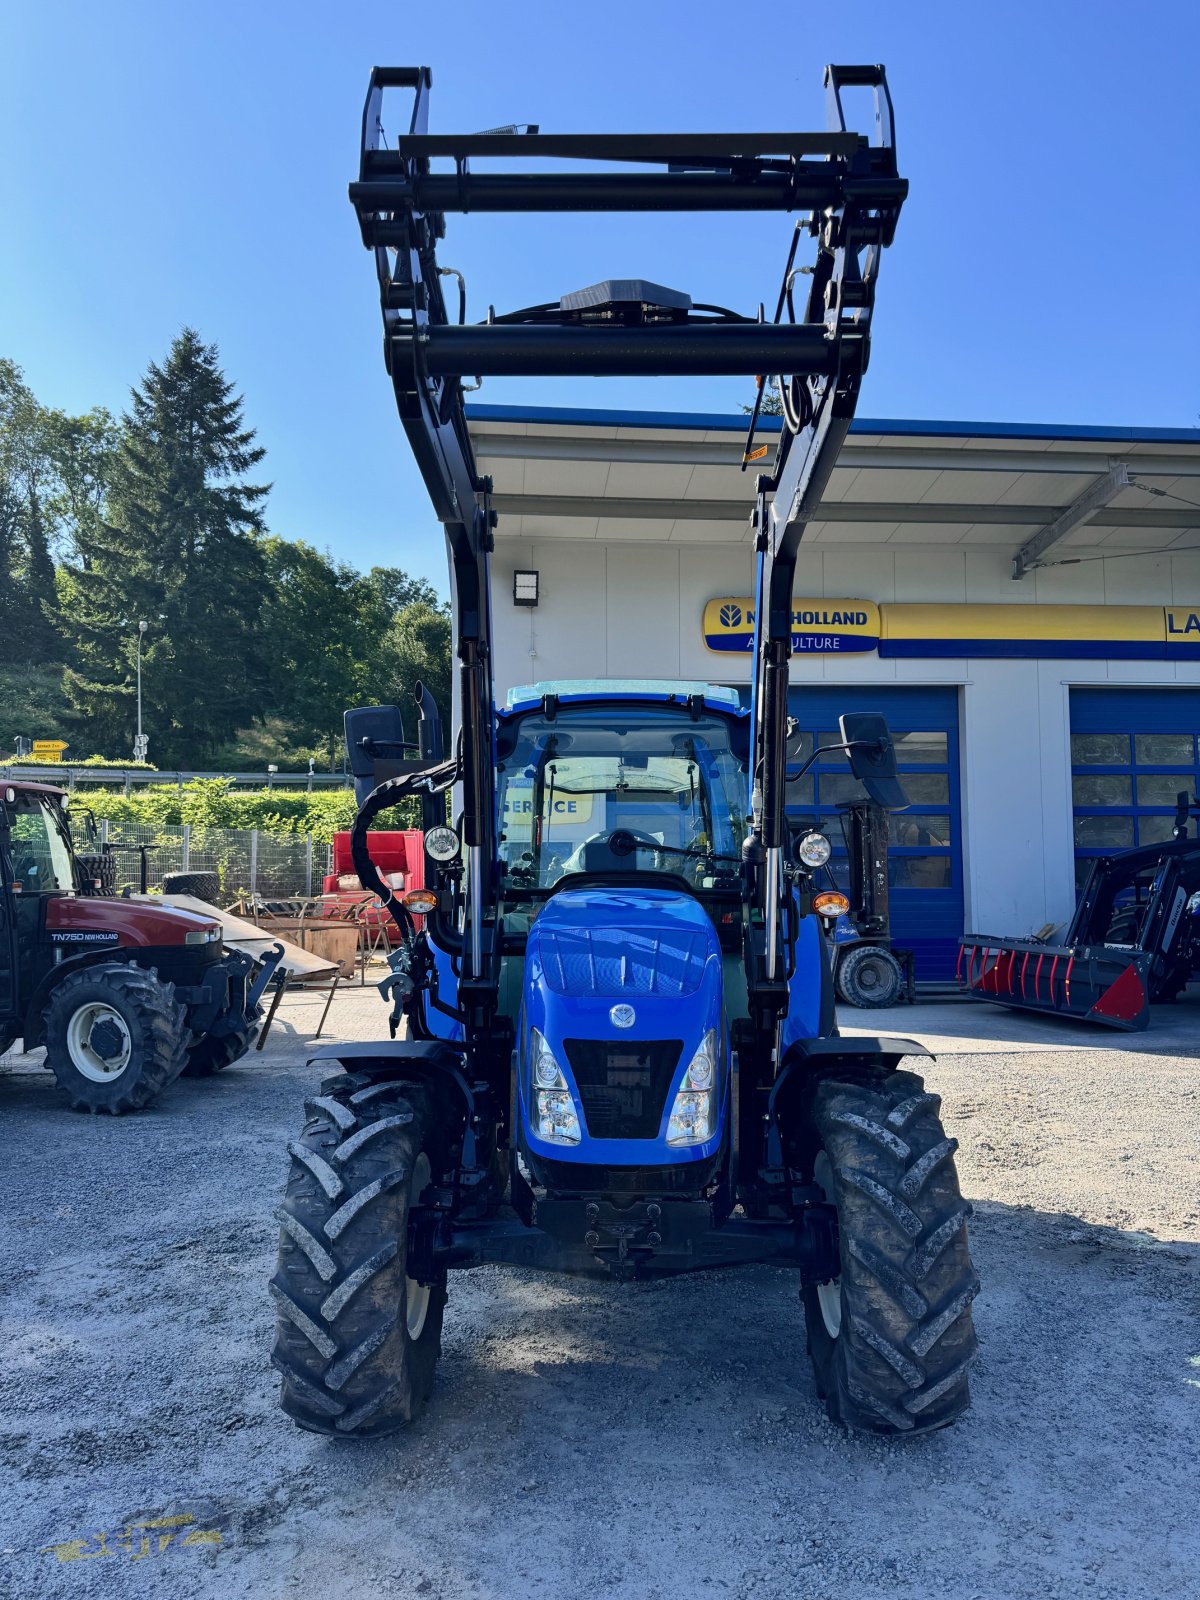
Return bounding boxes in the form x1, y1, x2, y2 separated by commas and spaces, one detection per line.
496, 683, 749, 1203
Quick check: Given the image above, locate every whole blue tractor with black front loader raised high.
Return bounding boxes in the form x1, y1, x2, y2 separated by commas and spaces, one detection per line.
272, 67, 978, 1437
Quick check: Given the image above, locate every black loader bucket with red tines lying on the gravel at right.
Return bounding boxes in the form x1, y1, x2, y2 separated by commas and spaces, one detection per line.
957, 933, 1150, 1032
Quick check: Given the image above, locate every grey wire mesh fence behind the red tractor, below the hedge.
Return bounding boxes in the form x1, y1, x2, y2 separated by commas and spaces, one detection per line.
98, 819, 333, 906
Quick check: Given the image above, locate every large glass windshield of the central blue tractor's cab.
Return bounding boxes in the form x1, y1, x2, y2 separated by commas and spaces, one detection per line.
498, 704, 746, 891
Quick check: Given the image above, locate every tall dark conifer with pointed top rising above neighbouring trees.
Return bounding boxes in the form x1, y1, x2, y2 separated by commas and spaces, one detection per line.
61, 328, 267, 765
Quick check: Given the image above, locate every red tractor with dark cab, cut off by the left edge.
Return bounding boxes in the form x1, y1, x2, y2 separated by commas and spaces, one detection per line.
0, 782, 282, 1115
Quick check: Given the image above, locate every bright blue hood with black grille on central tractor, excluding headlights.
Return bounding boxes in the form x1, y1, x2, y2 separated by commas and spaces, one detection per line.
518, 885, 726, 1166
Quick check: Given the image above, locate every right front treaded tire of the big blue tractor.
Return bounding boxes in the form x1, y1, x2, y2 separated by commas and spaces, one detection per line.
803, 1072, 979, 1434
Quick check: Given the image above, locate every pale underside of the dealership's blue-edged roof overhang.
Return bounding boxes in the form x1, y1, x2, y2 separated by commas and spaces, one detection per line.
467, 405, 1200, 574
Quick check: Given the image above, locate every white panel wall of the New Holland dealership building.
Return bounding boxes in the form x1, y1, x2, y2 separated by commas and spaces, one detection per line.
493, 538, 1200, 933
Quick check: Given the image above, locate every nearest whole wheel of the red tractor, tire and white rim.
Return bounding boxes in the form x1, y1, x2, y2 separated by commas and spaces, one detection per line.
45, 962, 187, 1117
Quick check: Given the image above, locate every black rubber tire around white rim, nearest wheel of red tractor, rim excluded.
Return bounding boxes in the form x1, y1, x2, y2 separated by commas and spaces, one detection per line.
45, 962, 187, 1117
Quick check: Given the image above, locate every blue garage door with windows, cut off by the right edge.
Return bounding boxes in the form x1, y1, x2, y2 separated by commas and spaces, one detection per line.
1070, 688, 1200, 883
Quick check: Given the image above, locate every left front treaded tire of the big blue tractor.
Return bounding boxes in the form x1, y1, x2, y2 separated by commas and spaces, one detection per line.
270, 1077, 446, 1438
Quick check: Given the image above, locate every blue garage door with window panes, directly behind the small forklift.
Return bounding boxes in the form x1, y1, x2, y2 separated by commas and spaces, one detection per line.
787, 686, 963, 982
